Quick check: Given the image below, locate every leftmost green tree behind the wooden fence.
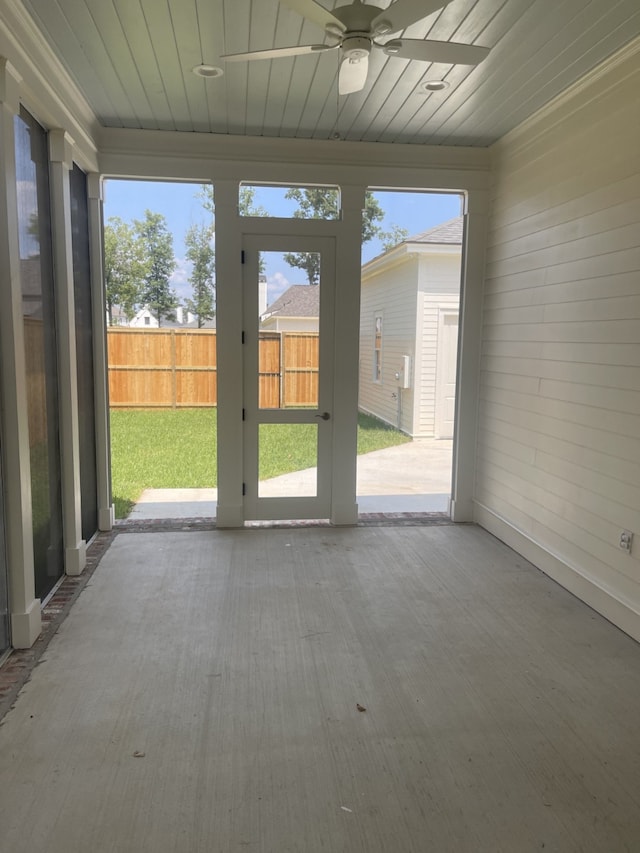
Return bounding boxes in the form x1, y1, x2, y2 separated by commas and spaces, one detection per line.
104, 216, 147, 325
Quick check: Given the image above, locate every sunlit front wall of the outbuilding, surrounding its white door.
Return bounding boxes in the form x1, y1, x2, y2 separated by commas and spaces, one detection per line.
416, 249, 460, 436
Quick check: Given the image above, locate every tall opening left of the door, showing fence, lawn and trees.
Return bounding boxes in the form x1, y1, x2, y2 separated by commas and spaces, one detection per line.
105, 180, 217, 518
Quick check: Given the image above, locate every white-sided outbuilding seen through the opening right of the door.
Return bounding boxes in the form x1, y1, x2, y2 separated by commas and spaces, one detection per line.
359, 217, 462, 438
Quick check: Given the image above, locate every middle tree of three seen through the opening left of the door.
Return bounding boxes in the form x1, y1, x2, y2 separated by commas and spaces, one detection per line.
134, 210, 178, 326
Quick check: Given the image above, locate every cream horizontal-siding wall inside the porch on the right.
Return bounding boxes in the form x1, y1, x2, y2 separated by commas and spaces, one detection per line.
476, 43, 640, 637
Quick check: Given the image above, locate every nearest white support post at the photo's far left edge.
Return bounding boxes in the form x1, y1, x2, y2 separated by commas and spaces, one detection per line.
0, 58, 41, 649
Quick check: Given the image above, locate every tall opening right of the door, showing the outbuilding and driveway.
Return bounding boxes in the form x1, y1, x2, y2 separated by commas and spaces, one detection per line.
357, 190, 463, 513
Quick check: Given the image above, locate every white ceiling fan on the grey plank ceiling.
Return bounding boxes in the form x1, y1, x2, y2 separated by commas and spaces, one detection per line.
221, 0, 489, 95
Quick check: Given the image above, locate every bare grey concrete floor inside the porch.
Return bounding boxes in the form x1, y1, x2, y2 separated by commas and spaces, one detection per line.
0, 524, 640, 853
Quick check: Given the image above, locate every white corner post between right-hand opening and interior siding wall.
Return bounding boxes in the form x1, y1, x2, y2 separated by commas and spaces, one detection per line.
450, 190, 488, 522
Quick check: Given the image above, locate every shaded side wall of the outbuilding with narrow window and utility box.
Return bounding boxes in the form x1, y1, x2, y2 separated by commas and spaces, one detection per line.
359, 256, 418, 433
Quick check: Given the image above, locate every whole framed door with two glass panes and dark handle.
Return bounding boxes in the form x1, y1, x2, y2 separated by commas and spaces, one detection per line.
244, 236, 335, 519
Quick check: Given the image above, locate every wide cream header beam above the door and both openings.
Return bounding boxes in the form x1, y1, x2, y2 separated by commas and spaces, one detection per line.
99, 128, 491, 193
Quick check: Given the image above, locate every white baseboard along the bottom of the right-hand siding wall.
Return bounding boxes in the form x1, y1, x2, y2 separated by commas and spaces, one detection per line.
474, 502, 640, 642
